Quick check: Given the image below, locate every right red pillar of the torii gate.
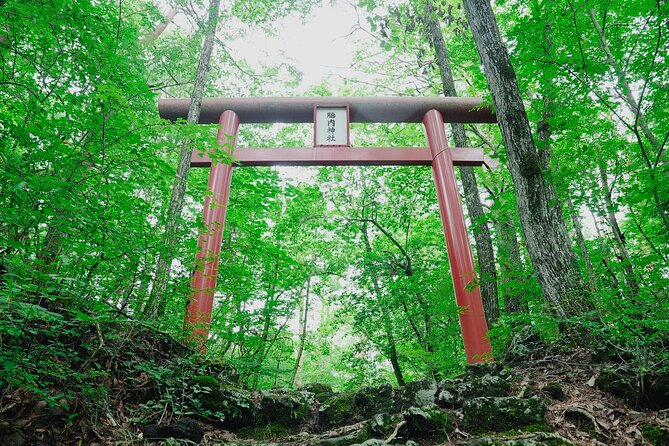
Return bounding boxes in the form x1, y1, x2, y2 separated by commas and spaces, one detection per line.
423, 110, 492, 364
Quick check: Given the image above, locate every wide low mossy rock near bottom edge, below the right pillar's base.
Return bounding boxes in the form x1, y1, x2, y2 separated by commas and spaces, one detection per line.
463, 397, 546, 433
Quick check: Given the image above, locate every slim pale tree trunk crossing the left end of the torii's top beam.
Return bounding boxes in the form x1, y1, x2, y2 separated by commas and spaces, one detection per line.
144, 0, 221, 316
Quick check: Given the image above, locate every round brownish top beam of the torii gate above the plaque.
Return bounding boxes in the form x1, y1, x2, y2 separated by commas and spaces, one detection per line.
158, 96, 490, 124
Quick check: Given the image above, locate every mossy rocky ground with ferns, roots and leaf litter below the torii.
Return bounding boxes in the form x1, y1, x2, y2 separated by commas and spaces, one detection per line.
0, 308, 669, 446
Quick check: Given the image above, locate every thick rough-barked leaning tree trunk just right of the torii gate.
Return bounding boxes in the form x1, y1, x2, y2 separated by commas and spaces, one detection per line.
464, 0, 592, 317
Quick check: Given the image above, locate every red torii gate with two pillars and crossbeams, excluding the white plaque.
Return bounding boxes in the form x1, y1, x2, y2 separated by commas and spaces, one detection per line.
158, 96, 496, 363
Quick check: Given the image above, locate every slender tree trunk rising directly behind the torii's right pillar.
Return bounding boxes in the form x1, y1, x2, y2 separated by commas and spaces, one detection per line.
424, 0, 499, 327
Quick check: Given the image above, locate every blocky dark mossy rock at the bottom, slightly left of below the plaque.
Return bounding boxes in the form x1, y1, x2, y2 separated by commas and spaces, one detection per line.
258, 389, 314, 426
